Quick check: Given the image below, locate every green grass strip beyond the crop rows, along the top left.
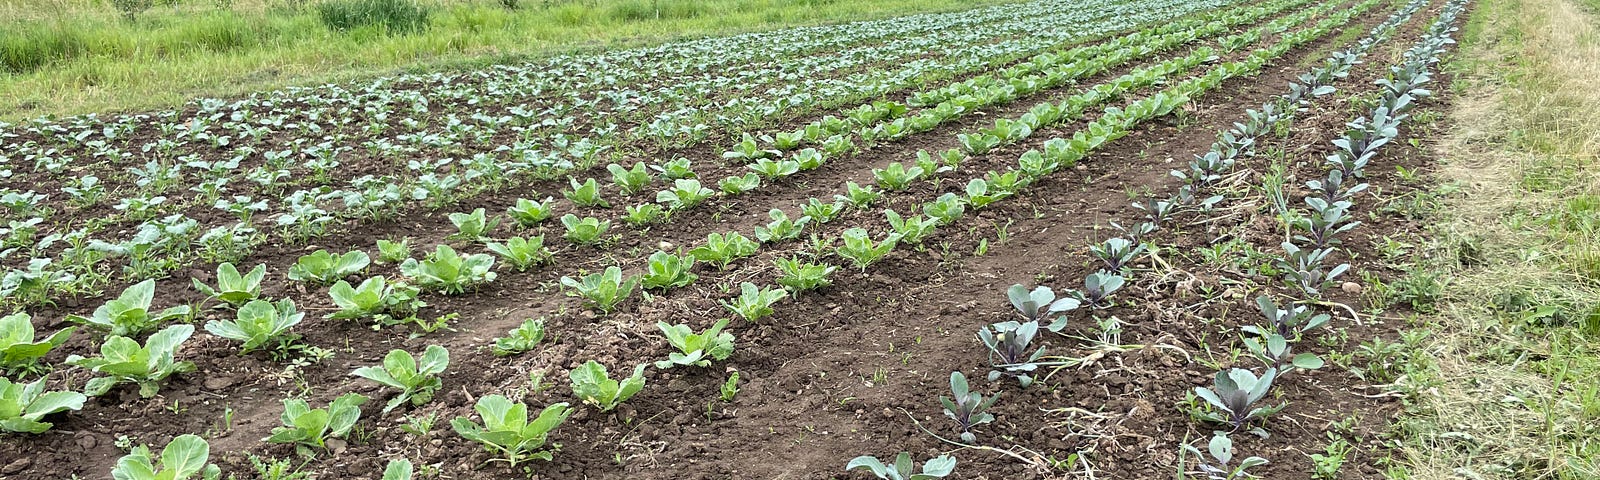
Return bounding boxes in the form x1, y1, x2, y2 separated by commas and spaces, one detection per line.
0, 0, 1018, 120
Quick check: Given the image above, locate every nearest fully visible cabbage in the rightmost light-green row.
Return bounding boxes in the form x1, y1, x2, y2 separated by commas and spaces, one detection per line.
450, 395, 573, 467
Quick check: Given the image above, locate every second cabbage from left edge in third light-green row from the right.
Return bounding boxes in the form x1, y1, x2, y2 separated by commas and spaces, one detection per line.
67, 323, 195, 398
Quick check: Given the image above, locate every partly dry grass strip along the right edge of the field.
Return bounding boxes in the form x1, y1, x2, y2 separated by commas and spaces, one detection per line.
1390, 0, 1600, 480
